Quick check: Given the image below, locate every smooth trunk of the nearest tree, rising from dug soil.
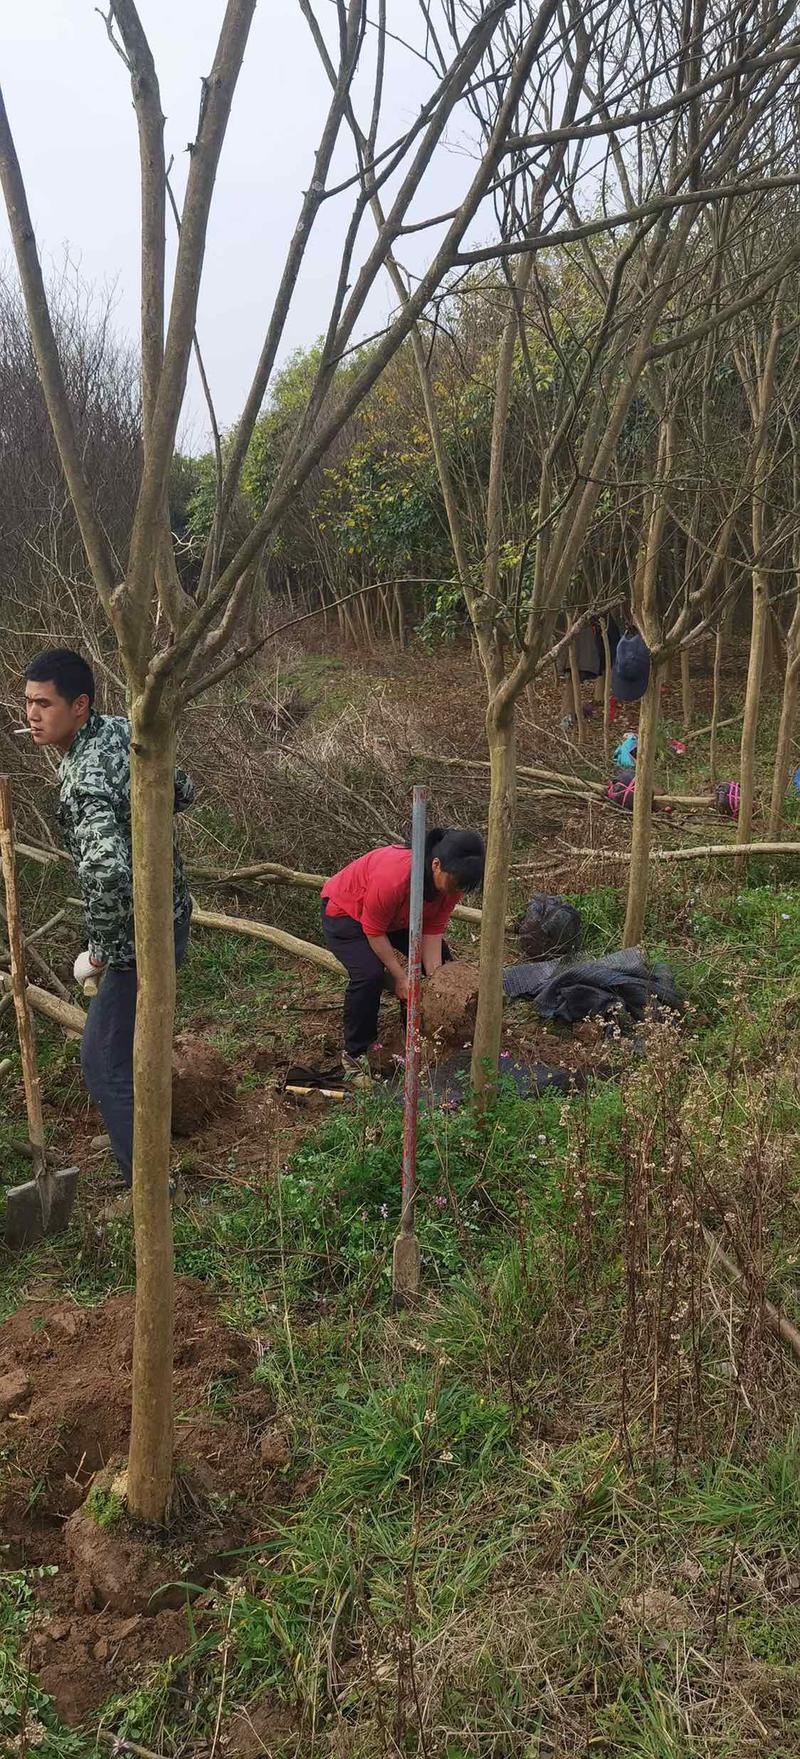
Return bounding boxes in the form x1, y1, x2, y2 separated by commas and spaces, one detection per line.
127, 698, 176, 1525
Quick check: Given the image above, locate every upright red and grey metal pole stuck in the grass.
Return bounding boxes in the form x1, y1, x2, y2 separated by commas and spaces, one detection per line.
392, 788, 427, 1307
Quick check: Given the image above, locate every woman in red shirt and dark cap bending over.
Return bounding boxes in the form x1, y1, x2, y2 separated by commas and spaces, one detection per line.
322, 827, 485, 1077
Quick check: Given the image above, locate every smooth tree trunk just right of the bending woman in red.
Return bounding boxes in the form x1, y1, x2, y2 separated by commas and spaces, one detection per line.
471, 704, 517, 1103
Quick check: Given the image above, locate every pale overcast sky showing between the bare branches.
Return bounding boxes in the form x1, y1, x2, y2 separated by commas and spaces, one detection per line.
0, 0, 471, 450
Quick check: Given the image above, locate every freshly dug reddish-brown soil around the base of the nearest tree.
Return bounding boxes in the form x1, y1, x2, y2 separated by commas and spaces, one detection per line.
0, 1279, 287, 1724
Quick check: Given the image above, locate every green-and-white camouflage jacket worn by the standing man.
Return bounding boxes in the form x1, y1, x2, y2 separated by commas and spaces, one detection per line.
58, 709, 195, 966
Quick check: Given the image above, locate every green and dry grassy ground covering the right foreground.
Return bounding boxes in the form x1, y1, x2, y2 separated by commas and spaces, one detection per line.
0, 657, 800, 1759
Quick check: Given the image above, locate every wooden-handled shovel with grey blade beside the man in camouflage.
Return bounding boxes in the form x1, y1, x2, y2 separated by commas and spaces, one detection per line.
0, 776, 77, 1249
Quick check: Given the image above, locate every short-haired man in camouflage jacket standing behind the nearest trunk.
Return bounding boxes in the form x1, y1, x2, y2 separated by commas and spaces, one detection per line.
25, 647, 195, 1186
